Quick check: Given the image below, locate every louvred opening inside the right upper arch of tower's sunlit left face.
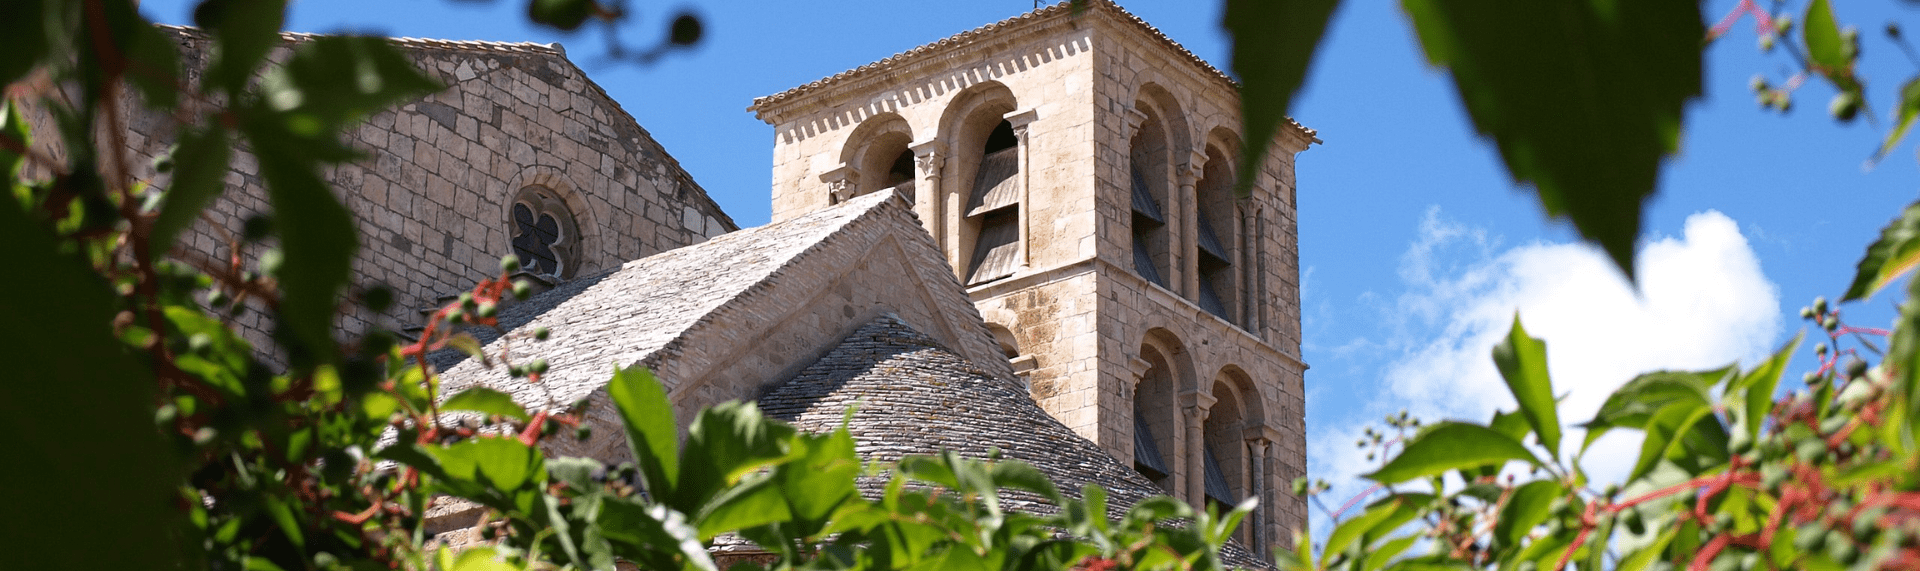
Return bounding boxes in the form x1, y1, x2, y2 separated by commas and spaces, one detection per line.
966, 119, 1021, 285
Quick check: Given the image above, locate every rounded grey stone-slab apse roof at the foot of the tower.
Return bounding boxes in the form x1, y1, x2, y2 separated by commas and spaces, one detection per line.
758, 315, 1267, 567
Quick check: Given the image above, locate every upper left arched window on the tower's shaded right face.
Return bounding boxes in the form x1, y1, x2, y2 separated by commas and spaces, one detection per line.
1127, 106, 1173, 288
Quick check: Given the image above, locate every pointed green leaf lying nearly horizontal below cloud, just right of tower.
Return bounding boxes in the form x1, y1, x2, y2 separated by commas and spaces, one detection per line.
1365, 421, 1540, 484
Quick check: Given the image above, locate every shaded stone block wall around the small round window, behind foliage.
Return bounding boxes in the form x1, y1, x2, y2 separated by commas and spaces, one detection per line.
40, 29, 737, 353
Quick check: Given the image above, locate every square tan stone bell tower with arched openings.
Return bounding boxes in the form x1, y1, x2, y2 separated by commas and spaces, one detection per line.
751, 0, 1317, 552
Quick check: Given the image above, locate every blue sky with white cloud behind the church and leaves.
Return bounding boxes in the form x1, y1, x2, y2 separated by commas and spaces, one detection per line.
142, 0, 1920, 522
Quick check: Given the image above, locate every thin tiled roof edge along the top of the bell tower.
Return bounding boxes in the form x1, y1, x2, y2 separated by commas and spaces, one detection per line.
747, 0, 1319, 138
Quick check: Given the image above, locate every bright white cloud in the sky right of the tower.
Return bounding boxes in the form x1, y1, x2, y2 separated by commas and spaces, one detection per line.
1309, 210, 1782, 530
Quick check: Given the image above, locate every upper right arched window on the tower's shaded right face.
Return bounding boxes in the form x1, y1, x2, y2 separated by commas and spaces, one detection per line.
1194, 144, 1240, 323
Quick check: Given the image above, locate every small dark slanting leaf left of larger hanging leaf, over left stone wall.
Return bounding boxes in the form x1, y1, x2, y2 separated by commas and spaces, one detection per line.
148, 127, 232, 260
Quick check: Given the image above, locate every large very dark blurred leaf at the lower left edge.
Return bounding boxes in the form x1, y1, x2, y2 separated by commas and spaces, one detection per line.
0, 184, 176, 569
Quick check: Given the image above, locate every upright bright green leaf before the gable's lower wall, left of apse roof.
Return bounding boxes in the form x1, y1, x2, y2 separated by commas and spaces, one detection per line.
607, 365, 680, 498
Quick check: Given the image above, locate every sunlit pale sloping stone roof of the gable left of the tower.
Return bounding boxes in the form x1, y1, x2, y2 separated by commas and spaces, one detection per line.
434, 192, 893, 408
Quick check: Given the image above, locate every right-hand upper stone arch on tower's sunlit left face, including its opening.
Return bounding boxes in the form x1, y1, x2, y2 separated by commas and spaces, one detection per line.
939, 81, 1021, 286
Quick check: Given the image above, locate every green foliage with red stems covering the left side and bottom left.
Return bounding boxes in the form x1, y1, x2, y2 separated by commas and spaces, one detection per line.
0, 0, 1252, 571
